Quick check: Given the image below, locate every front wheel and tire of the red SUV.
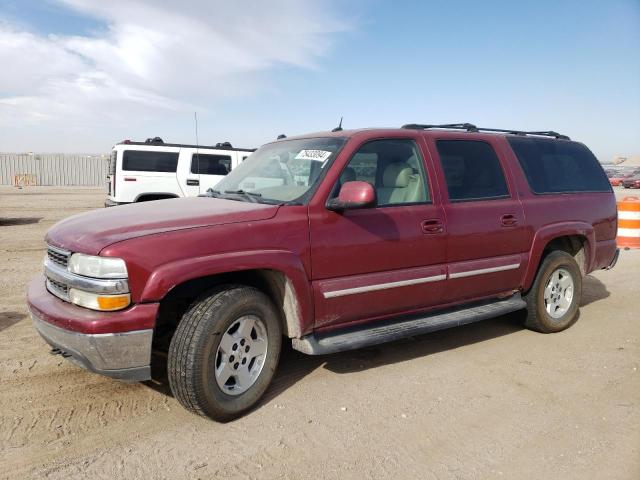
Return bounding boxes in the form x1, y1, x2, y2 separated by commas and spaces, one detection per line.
167, 285, 282, 422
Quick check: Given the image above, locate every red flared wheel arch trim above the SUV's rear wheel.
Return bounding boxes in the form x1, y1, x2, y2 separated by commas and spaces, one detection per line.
523, 222, 596, 292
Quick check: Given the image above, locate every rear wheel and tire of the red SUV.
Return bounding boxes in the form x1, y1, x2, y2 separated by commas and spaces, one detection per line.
524, 250, 582, 333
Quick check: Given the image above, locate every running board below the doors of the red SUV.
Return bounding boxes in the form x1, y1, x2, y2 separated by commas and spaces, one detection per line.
292, 293, 527, 355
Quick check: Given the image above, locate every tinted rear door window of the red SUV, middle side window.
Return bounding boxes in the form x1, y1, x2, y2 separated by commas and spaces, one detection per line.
437, 140, 509, 202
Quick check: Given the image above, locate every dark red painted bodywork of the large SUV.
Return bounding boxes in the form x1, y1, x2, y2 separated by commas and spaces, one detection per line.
29, 129, 617, 333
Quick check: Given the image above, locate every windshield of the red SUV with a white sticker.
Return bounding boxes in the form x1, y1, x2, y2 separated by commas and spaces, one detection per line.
214, 137, 346, 202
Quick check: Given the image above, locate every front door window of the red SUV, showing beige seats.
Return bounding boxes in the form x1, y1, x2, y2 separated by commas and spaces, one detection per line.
332, 139, 431, 207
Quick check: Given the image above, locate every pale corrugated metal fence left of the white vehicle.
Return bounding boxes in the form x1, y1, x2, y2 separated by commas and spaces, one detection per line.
0, 153, 109, 187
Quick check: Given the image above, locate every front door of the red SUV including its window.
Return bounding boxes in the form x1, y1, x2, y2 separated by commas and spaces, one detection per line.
309, 138, 446, 328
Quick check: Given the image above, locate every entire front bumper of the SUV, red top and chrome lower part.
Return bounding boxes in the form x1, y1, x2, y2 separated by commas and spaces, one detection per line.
27, 277, 158, 381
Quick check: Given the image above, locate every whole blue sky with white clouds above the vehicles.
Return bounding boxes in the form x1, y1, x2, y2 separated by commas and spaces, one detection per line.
0, 0, 640, 161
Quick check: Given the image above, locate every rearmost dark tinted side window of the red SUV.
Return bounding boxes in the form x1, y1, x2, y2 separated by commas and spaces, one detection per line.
509, 137, 611, 193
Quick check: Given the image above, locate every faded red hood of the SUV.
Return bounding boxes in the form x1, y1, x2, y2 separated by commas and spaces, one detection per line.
46, 197, 279, 255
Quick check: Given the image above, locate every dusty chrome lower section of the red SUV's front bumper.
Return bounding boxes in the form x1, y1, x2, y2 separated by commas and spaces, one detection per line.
30, 311, 153, 381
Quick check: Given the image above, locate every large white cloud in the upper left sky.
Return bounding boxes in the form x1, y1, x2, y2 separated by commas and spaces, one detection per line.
0, 0, 348, 146
